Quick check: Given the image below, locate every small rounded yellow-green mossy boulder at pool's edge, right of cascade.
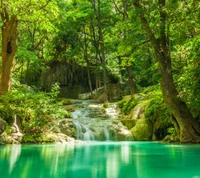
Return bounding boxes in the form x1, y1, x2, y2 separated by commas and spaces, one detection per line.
131, 119, 152, 141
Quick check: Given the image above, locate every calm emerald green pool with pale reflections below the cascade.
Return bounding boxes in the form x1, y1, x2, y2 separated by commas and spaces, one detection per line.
0, 142, 200, 178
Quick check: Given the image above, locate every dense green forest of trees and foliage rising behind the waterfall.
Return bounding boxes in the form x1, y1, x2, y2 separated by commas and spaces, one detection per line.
0, 0, 200, 142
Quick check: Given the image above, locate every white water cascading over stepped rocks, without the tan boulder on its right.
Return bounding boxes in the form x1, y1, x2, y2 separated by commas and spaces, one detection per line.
71, 101, 119, 140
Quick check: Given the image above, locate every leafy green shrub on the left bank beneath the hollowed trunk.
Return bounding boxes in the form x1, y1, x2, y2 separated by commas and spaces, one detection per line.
0, 83, 67, 140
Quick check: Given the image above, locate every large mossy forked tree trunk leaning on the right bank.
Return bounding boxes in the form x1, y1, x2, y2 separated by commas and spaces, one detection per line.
134, 0, 200, 143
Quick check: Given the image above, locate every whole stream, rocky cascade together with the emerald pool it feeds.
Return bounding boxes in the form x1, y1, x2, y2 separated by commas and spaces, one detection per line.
0, 101, 200, 178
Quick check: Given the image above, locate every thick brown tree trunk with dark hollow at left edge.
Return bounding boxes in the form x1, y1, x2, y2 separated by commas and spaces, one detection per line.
0, 15, 18, 94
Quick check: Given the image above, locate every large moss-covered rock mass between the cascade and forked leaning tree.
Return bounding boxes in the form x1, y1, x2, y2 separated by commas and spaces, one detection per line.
118, 87, 173, 140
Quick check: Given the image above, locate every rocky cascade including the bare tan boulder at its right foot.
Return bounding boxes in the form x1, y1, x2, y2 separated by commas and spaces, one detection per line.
67, 100, 133, 141
